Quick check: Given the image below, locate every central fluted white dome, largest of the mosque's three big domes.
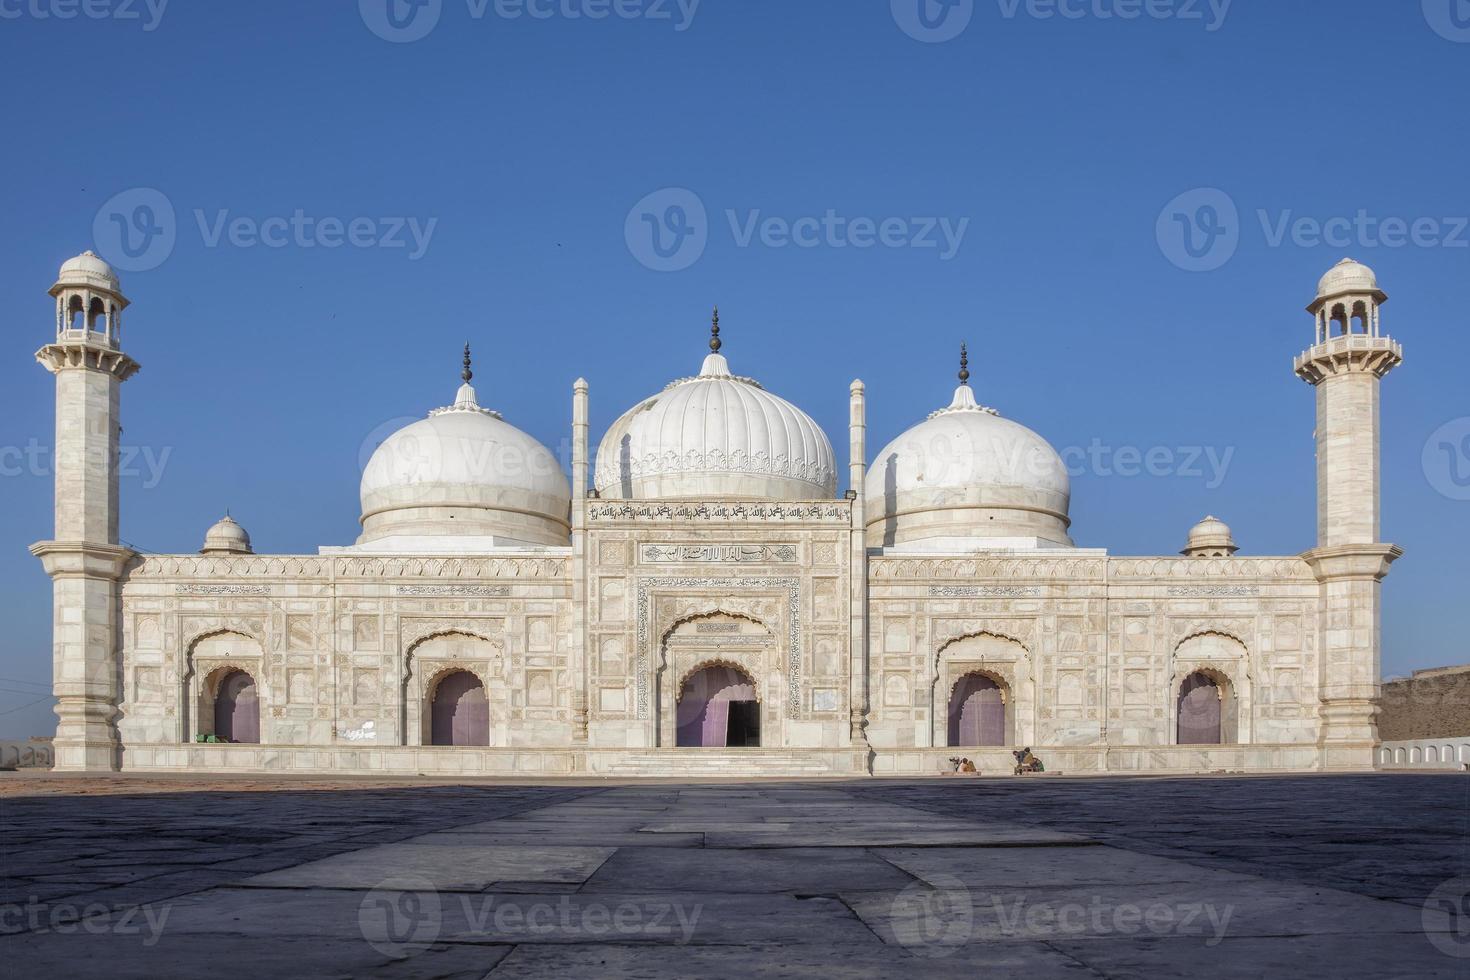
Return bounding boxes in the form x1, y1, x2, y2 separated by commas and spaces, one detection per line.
592, 338, 836, 500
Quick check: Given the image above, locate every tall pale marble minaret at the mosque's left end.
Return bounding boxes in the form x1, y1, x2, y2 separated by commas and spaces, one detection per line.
31, 251, 138, 771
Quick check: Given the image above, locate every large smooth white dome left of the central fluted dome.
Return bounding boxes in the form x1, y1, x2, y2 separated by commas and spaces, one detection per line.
357, 369, 572, 550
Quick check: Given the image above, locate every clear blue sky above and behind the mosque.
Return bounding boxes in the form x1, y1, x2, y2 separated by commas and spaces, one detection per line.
0, 0, 1470, 736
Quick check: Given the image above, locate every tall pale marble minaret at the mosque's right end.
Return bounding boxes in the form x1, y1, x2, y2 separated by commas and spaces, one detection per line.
1297, 259, 1404, 768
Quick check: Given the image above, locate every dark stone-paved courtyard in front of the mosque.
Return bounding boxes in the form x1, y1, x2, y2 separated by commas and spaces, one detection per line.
0, 774, 1470, 980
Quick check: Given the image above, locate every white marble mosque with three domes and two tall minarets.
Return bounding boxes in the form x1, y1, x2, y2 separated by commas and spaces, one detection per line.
32, 253, 1402, 776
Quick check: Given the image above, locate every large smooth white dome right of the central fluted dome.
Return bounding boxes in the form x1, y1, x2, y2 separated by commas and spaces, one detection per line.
864, 383, 1072, 550
